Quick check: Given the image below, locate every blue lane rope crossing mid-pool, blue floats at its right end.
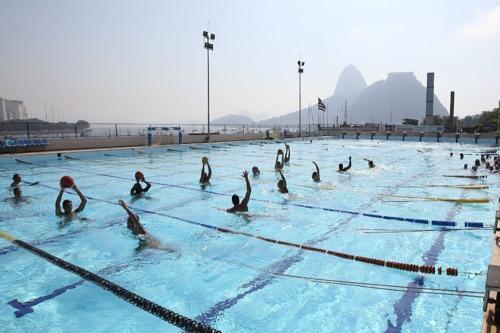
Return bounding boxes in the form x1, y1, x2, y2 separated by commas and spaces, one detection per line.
15, 158, 489, 227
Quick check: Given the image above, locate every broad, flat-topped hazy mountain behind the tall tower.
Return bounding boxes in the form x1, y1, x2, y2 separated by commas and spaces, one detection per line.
348, 72, 448, 124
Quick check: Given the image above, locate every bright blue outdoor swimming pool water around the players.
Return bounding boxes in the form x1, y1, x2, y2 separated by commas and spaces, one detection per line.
0, 139, 492, 332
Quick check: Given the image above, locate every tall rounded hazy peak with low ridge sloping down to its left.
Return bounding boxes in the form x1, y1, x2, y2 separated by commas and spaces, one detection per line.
262, 65, 366, 125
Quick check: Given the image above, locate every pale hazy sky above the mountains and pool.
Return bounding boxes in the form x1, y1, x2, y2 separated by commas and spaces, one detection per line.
0, 0, 500, 123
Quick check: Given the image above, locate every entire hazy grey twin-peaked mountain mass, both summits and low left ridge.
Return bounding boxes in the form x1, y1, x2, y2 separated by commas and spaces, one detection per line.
262, 65, 448, 125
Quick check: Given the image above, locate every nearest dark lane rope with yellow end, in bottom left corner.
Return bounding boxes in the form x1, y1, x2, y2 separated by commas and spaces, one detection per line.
0, 230, 220, 333
